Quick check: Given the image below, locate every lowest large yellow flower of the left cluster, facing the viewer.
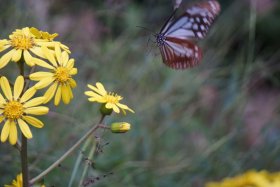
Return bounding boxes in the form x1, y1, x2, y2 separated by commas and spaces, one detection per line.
0, 76, 49, 145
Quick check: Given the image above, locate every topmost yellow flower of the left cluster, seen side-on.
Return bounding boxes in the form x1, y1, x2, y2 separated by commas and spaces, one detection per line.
0, 27, 70, 69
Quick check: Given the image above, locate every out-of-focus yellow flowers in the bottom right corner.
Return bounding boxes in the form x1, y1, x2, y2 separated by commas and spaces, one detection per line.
205, 170, 280, 187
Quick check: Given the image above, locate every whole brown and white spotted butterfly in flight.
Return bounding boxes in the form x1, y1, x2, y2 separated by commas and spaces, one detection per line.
155, 0, 220, 69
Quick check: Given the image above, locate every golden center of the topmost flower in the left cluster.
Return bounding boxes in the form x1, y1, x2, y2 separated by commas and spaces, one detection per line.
11, 34, 34, 50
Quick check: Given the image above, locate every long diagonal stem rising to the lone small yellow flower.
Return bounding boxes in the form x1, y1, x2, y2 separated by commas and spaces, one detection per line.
29, 120, 102, 185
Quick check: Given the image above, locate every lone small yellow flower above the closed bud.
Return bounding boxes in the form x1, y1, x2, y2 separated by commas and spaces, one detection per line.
85, 82, 134, 114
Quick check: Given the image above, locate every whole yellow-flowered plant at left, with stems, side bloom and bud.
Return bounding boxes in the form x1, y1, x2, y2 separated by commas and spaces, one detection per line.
0, 27, 134, 187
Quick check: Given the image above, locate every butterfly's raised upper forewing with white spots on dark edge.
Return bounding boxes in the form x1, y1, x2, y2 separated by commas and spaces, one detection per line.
161, 0, 220, 39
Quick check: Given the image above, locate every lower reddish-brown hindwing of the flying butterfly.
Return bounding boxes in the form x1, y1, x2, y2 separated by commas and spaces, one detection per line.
159, 37, 202, 69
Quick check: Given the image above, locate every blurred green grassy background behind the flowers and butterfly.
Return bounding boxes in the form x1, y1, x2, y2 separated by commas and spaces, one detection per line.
0, 0, 280, 187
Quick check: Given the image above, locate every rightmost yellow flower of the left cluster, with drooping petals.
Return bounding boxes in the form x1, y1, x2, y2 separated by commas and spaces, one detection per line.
29, 46, 78, 105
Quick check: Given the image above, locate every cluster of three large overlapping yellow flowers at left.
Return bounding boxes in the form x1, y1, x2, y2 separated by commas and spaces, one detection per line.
0, 27, 78, 145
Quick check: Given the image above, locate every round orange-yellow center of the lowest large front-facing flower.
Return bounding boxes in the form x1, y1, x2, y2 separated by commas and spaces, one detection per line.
4, 101, 23, 120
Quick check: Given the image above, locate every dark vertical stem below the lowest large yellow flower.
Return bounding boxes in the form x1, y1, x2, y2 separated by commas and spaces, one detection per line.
20, 134, 28, 187
